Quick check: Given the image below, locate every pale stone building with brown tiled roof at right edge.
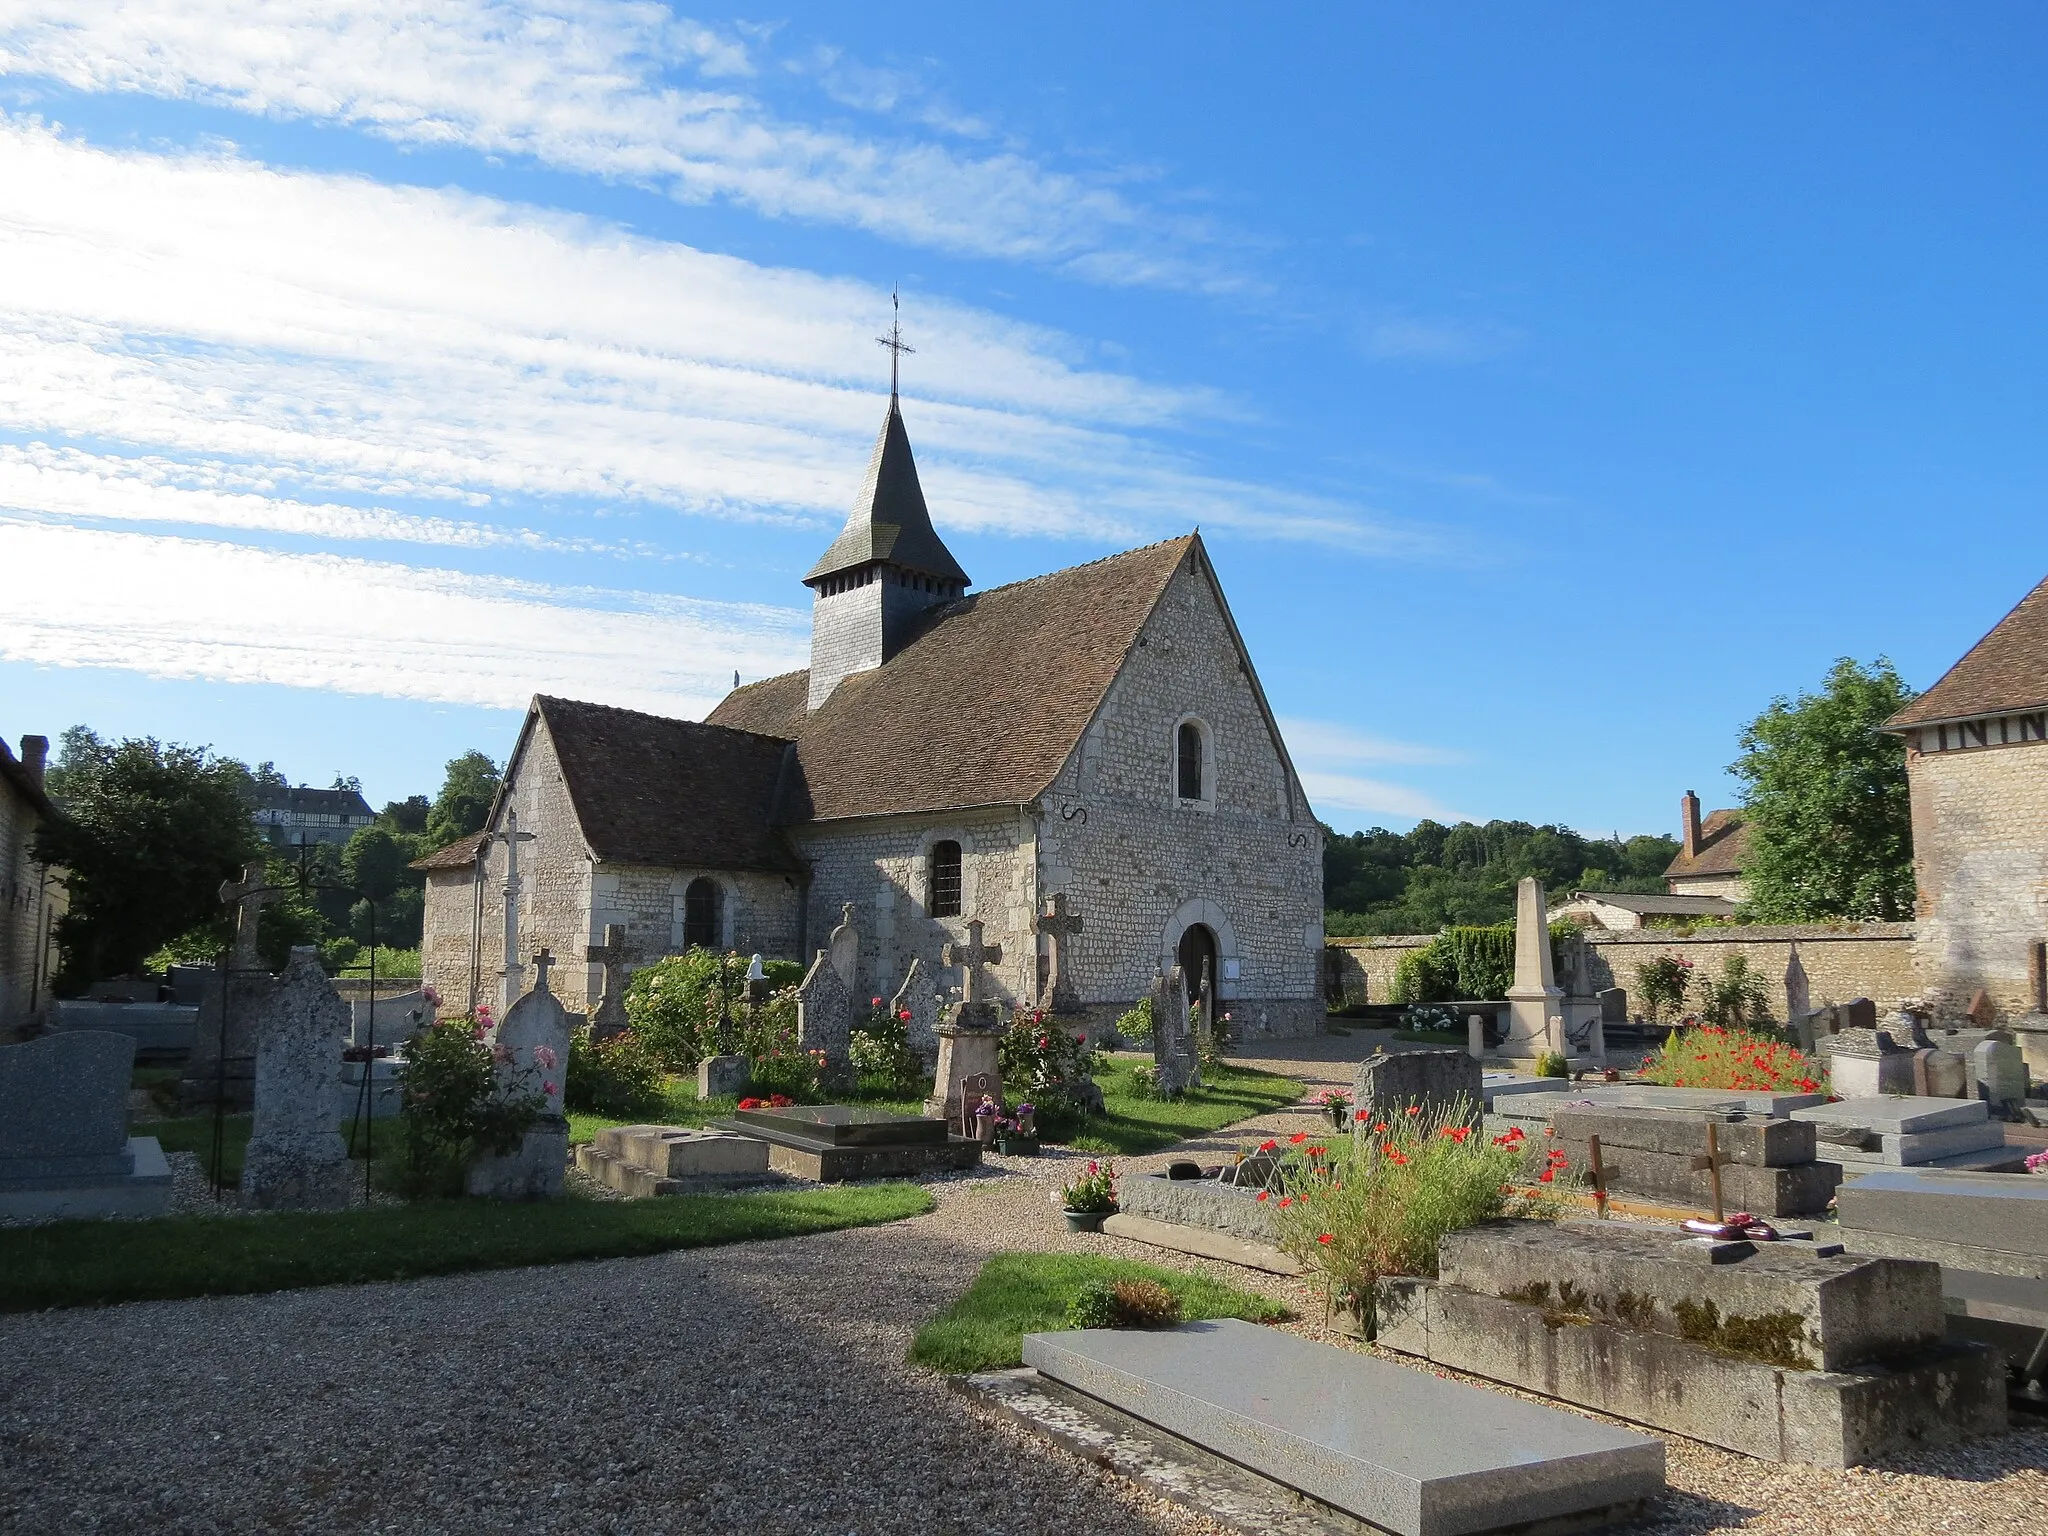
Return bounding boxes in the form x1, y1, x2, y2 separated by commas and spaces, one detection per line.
1886, 582, 2048, 1016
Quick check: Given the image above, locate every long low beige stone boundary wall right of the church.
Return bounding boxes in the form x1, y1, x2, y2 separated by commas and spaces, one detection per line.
1323, 922, 1921, 1022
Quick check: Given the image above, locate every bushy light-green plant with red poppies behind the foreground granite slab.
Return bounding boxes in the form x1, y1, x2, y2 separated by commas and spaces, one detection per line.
1260, 1102, 1573, 1329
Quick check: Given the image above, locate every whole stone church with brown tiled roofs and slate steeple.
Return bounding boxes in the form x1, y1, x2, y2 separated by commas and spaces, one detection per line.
420, 395, 1323, 1036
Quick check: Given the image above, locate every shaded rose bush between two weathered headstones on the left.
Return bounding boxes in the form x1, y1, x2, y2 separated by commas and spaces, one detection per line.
399, 1006, 547, 1200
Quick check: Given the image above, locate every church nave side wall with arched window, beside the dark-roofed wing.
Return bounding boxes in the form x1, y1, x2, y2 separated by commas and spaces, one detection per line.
797, 811, 1036, 1006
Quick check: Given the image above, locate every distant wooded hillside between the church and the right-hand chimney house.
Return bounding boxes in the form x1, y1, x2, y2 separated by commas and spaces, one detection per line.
1323, 821, 1677, 934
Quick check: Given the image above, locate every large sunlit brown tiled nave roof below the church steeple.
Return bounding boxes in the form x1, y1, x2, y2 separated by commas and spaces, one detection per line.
707, 535, 1200, 821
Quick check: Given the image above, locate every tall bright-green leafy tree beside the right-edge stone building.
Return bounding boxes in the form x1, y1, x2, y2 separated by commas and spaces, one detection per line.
1731, 655, 1913, 922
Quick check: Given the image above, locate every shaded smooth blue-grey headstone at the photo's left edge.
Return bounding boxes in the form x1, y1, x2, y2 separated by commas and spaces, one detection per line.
0, 1030, 135, 1178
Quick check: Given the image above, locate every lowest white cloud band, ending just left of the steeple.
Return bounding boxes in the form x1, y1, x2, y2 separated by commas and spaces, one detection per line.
0, 518, 807, 715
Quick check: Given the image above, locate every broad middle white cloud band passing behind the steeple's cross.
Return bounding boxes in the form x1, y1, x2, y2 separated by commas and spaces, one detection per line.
0, 117, 1430, 553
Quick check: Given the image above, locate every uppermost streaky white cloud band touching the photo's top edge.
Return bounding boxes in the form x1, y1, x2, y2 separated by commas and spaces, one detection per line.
0, 0, 1237, 289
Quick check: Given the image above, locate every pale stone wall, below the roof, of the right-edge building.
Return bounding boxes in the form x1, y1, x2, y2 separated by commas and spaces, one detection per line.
1907, 741, 2048, 1018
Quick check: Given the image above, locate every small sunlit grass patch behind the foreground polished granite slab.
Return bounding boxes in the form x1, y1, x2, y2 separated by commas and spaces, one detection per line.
909, 1253, 1288, 1372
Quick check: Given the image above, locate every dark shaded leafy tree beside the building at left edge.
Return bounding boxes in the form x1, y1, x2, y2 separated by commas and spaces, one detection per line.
37, 725, 258, 991
